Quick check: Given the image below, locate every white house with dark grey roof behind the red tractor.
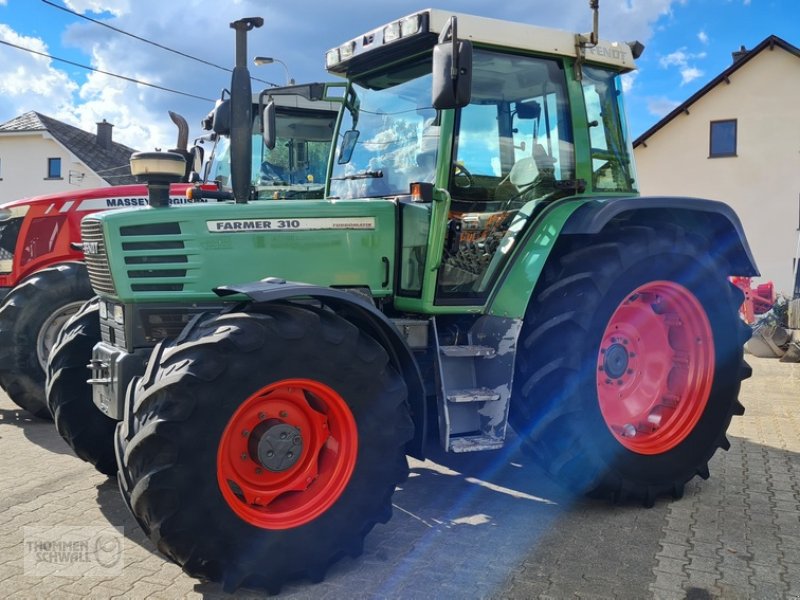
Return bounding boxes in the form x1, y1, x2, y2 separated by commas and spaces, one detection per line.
0, 111, 135, 204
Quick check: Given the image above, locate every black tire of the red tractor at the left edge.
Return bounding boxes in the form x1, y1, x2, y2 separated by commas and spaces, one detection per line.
0, 262, 94, 419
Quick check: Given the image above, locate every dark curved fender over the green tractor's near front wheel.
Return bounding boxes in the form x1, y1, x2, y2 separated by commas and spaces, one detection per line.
214, 277, 427, 458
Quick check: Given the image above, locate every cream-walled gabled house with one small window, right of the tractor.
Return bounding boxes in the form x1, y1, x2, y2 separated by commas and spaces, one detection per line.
634, 35, 800, 297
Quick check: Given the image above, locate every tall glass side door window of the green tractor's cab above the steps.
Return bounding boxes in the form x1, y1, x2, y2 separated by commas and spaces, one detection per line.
437, 50, 575, 304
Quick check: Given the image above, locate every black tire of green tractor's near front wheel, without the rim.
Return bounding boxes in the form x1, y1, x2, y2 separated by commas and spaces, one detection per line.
116, 305, 413, 593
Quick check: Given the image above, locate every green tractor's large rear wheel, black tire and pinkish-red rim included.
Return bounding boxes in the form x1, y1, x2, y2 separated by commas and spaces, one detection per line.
510, 226, 750, 506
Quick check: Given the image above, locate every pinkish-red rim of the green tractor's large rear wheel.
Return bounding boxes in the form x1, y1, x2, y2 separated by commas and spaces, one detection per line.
597, 281, 714, 454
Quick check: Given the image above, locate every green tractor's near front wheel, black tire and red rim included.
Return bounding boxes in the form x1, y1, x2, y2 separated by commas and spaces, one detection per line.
116, 305, 413, 593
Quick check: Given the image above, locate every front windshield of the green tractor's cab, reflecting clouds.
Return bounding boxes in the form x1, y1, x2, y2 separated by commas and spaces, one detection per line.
330, 57, 439, 198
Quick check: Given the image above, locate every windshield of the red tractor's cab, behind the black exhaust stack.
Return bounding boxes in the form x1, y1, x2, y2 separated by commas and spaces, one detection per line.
208, 107, 336, 199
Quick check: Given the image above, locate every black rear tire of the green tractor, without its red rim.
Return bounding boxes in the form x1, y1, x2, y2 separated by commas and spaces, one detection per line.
510, 225, 751, 506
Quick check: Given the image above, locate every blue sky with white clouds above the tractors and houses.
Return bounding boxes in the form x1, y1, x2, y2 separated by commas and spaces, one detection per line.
0, 0, 800, 149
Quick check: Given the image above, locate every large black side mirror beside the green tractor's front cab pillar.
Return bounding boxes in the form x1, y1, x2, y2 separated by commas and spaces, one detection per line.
431, 17, 472, 110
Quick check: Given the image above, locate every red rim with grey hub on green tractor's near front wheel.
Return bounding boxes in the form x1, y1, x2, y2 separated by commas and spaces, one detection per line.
217, 379, 358, 529
